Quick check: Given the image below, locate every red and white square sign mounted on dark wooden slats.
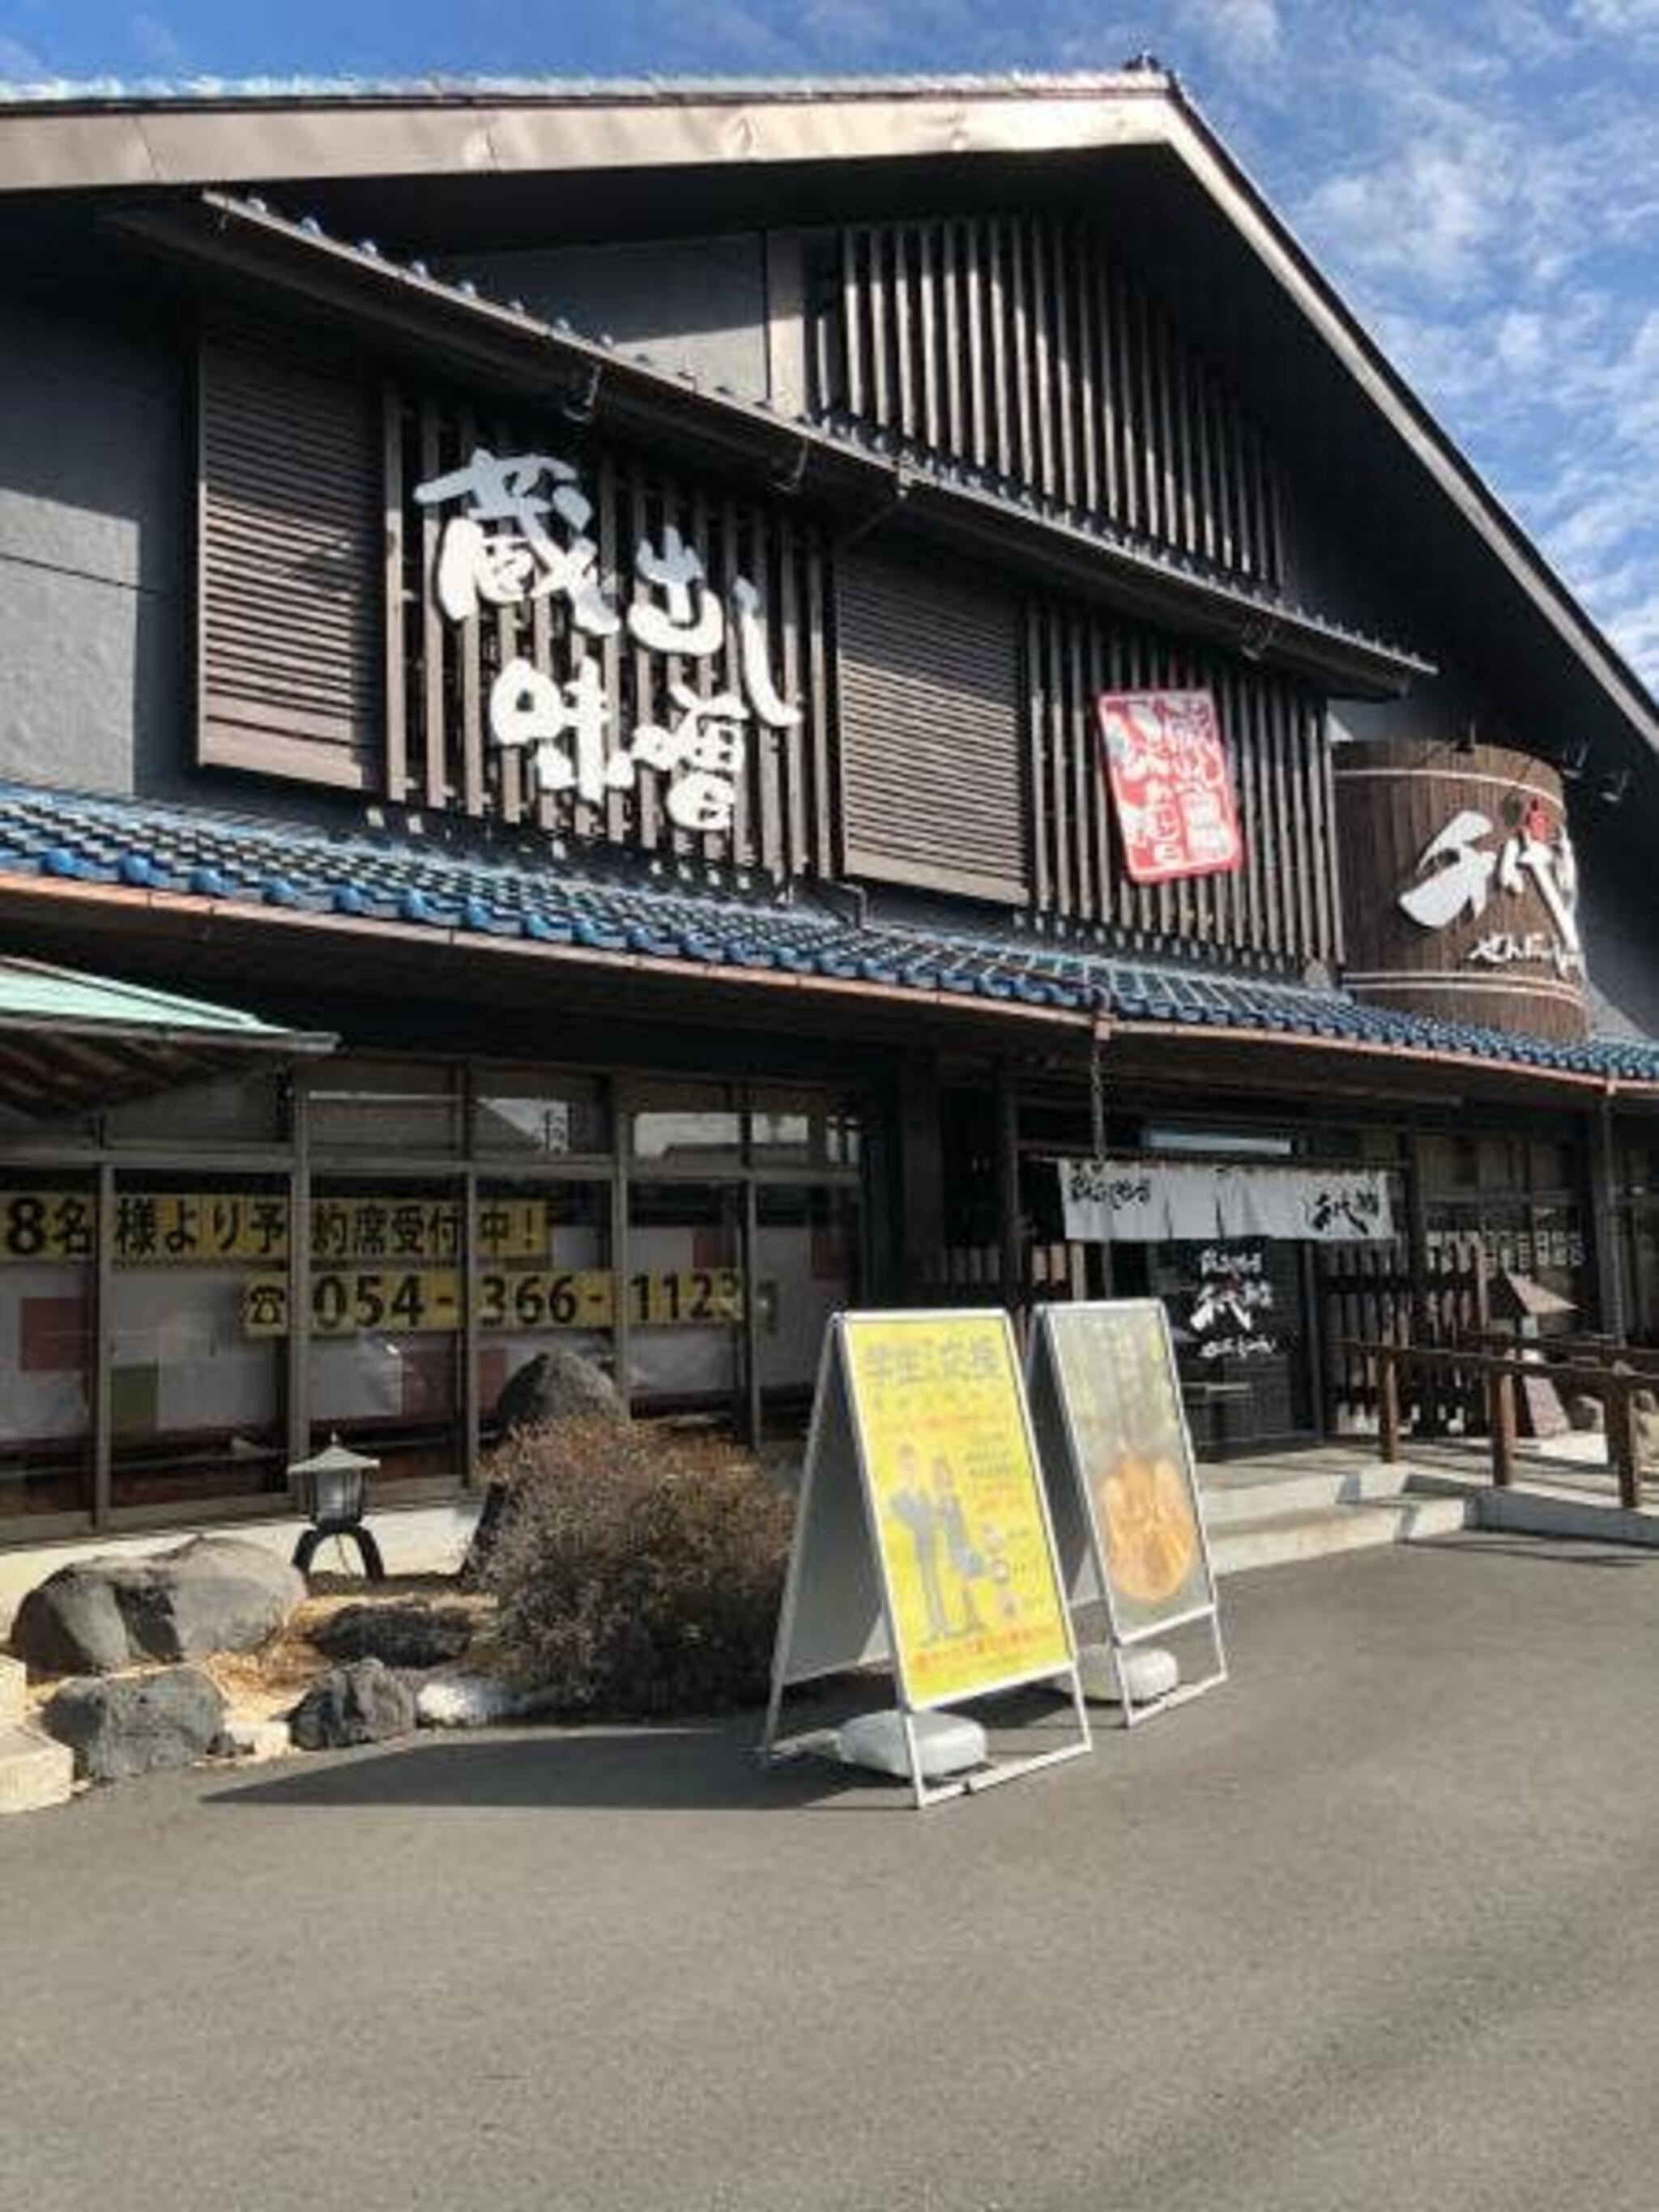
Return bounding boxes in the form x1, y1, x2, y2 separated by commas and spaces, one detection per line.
1097, 693, 1243, 883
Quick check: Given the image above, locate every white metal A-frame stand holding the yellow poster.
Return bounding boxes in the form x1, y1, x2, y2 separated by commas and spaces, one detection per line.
761, 1307, 1093, 1809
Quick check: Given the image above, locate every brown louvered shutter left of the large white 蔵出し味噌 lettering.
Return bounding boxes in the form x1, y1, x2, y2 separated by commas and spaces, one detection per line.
199, 336, 385, 792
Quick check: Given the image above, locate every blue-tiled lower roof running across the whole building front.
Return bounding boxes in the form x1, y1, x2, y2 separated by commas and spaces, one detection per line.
0, 786, 1659, 1099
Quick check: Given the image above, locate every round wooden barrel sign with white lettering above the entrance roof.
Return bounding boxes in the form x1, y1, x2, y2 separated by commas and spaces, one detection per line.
1332, 741, 1590, 1038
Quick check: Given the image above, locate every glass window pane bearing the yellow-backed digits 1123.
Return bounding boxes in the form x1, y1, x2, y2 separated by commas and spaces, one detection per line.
626, 1183, 744, 1418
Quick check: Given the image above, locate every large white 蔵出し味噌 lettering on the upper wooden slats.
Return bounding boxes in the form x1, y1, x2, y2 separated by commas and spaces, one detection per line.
414, 447, 801, 832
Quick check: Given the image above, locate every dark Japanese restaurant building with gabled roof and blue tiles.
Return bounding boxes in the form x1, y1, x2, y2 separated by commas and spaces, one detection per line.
0, 64, 1659, 1544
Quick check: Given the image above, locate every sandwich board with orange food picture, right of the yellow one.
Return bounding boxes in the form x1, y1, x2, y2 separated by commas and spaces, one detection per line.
1026, 1298, 1228, 1728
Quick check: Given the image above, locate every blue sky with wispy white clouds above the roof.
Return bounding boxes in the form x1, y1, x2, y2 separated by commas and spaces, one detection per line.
0, 0, 1659, 688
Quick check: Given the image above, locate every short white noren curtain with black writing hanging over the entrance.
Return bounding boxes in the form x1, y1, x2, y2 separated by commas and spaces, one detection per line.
1060, 1159, 1393, 1243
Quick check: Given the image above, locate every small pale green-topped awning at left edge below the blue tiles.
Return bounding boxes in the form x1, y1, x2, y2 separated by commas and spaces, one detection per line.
0, 958, 334, 1122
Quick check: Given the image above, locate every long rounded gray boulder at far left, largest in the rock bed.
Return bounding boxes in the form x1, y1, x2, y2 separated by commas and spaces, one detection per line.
11, 1535, 305, 1674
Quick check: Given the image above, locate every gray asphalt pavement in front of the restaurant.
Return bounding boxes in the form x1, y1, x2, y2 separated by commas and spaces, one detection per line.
0, 1535, 1659, 2212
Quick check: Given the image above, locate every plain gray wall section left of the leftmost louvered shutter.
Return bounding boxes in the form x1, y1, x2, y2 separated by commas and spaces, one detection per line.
0, 303, 193, 792
